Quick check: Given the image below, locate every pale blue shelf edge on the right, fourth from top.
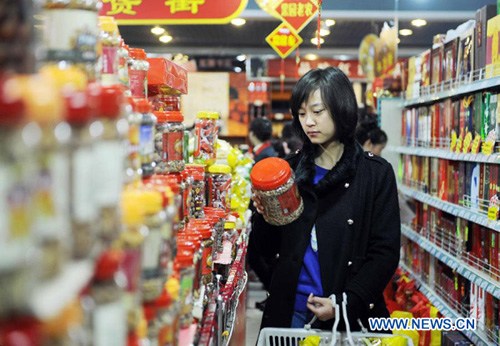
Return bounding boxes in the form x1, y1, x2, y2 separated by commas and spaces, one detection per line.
401, 225, 500, 299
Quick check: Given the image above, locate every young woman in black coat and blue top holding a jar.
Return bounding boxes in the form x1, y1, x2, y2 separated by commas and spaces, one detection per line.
249, 67, 400, 330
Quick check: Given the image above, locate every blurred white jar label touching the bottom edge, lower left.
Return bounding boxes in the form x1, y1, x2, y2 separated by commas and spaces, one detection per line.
92, 300, 127, 346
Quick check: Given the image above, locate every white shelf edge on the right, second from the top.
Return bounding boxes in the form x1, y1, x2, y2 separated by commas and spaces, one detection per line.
388, 146, 500, 164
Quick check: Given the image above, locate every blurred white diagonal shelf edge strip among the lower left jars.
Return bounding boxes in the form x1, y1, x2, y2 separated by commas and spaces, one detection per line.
30, 260, 94, 319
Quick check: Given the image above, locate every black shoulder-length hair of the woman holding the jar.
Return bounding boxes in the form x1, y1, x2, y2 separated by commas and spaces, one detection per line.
290, 67, 358, 146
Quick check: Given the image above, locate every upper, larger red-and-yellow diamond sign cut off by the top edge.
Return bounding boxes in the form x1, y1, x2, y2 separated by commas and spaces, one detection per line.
275, 0, 318, 32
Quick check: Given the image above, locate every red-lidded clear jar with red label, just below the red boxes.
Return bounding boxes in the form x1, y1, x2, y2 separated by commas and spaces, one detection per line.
154, 111, 185, 174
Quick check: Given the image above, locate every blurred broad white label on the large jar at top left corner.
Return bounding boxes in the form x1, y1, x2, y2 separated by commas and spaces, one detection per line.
43, 9, 98, 63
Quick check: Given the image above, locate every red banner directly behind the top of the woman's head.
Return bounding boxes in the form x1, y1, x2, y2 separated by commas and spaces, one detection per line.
267, 59, 366, 80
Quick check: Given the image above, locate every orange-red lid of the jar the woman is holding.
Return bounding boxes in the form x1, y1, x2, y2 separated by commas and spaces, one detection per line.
250, 157, 292, 191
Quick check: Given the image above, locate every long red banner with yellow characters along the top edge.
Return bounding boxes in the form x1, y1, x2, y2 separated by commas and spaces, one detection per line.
99, 0, 248, 25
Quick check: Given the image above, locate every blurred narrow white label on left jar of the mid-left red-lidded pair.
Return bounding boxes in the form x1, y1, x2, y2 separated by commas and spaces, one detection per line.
70, 148, 97, 223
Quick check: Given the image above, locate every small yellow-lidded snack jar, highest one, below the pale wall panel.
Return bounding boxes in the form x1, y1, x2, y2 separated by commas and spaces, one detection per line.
193, 112, 219, 165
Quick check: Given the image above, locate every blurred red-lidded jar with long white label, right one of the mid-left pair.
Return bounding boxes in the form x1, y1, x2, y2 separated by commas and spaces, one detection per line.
90, 86, 128, 245
